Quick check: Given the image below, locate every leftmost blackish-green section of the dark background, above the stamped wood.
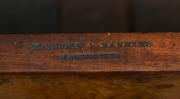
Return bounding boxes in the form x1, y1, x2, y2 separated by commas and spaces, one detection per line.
0, 0, 61, 33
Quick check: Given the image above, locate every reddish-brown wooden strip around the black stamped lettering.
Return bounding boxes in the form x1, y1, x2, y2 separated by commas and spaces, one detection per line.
0, 33, 180, 72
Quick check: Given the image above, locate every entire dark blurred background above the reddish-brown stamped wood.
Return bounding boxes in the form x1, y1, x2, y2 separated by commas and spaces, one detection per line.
0, 0, 180, 33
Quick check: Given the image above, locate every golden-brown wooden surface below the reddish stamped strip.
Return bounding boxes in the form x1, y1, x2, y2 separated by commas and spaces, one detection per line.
0, 72, 180, 99
